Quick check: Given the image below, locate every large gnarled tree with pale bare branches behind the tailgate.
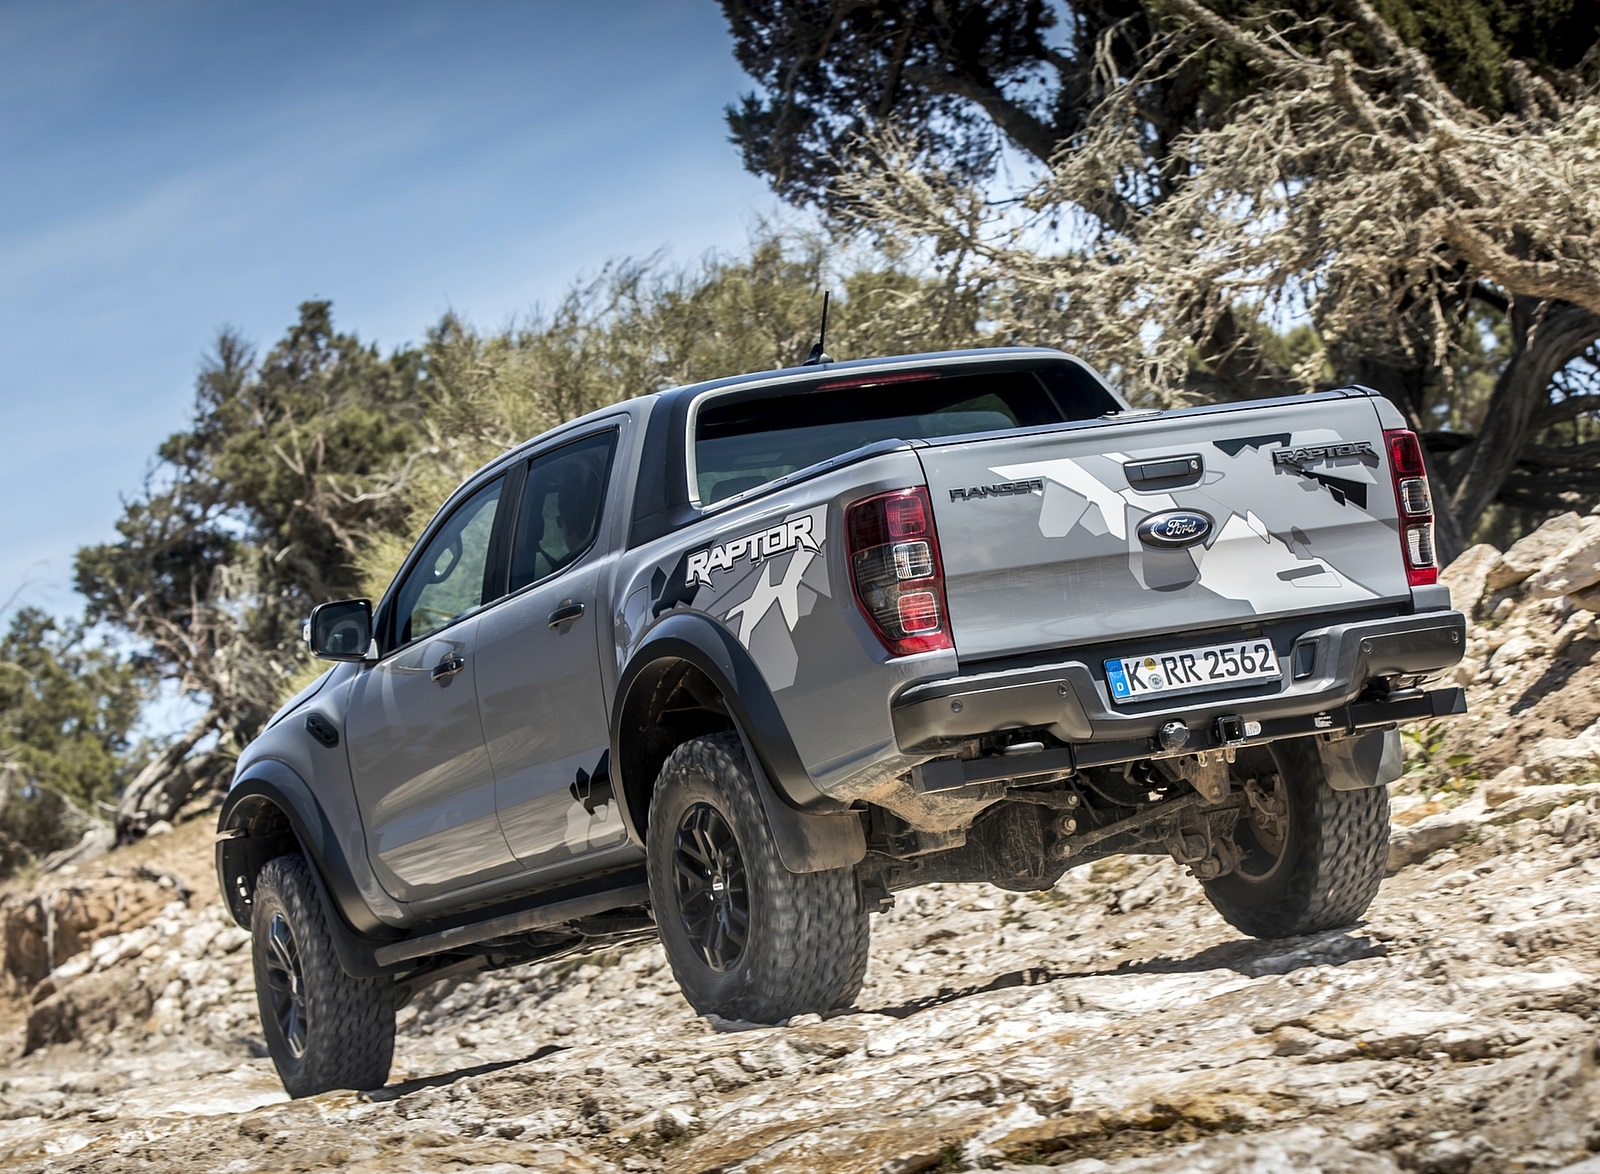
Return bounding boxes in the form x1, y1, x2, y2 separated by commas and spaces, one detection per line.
736, 0, 1600, 557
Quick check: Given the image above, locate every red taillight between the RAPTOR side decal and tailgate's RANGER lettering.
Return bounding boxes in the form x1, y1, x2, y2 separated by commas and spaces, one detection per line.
845, 486, 954, 656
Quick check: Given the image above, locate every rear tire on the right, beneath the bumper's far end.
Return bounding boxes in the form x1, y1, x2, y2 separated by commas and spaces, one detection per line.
1205, 737, 1389, 937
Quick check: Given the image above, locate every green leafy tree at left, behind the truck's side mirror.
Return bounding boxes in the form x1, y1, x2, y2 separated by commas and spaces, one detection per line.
77, 302, 422, 835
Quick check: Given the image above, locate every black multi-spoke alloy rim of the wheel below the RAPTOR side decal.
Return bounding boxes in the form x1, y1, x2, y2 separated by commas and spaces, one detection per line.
674, 803, 750, 974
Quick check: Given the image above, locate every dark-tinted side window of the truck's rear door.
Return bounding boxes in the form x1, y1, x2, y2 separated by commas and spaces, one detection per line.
510, 430, 616, 590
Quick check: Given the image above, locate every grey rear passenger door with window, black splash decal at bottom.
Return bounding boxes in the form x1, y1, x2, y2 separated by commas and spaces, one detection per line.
477, 429, 627, 872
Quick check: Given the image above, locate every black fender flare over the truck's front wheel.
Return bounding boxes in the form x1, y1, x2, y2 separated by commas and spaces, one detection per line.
216, 758, 400, 977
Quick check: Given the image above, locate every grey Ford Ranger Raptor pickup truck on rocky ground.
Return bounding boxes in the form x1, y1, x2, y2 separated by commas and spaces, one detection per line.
216, 349, 1464, 1096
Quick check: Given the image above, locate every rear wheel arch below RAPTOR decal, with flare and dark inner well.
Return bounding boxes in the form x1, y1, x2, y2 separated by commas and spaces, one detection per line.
611, 613, 866, 872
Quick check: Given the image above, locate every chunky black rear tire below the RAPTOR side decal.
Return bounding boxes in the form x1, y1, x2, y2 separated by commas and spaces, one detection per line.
645, 734, 870, 1024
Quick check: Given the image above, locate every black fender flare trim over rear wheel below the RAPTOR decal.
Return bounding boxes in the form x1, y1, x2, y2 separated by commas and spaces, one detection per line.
611, 613, 867, 872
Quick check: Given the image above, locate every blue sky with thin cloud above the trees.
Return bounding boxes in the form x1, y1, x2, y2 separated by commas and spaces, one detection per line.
0, 0, 778, 613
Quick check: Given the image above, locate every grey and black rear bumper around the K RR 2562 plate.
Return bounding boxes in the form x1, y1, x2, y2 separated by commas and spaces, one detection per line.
890, 611, 1467, 765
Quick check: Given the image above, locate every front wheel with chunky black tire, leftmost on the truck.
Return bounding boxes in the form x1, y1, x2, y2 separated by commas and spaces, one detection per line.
250, 853, 395, 1097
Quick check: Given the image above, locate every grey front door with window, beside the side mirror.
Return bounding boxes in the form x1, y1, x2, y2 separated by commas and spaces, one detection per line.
346, 478, 520, 900
